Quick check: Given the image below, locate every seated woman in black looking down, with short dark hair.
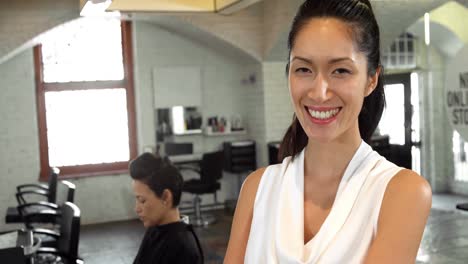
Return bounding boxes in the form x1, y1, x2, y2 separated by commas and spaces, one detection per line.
130, 153, 203, 264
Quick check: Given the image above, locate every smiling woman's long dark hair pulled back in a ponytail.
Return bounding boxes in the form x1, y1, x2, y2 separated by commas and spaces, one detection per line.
278, 0, 385, 161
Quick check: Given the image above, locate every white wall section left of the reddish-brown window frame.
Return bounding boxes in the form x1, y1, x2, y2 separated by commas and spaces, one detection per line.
0, 50, 39, 231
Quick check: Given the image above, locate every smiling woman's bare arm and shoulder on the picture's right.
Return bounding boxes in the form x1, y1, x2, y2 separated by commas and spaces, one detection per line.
364, 170, 432, 264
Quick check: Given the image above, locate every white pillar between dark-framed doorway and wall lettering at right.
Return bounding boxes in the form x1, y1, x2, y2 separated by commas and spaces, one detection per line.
417, 40, 453, 193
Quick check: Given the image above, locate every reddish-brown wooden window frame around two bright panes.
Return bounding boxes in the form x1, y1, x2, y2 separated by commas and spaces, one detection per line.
33, 21, 137, 181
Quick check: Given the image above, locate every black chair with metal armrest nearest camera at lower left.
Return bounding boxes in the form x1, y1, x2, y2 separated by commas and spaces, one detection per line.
35, 202, 83, 264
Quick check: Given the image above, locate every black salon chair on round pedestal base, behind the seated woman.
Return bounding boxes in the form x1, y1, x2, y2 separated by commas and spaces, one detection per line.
179, 151, 224, 226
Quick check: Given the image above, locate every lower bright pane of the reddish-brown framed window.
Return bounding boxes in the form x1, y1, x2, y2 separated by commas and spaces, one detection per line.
45, 88, 130, 166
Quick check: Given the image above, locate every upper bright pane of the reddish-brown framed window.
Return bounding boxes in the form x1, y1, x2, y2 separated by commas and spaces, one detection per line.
41, 18, 124, 83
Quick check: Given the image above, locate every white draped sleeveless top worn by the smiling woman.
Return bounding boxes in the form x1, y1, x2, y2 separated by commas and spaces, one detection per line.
244, 141, 402, 264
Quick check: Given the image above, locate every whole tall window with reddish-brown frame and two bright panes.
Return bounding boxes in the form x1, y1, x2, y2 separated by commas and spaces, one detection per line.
34, 18, 136, 179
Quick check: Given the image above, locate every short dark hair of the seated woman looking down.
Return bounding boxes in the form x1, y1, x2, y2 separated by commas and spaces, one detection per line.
129, 153, 184, 208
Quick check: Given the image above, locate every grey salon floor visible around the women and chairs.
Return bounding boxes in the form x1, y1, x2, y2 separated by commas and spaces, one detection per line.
80, 195, 468, 264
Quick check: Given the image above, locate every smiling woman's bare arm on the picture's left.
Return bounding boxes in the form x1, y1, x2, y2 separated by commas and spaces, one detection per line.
224, 168, 265, 264
